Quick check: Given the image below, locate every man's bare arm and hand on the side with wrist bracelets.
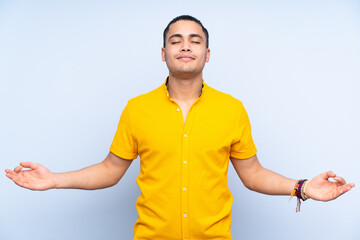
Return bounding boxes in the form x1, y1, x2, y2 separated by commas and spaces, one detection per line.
230, 155, 355, 201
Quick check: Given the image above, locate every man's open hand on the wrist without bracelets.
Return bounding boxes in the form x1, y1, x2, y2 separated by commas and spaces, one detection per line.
5, 162, 56, 190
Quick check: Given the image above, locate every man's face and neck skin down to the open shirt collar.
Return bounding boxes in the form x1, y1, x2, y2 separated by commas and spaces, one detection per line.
161, 20, 210, 123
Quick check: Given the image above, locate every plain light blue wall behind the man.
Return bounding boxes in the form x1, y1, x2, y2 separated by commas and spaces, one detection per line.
0, 0, 360, 240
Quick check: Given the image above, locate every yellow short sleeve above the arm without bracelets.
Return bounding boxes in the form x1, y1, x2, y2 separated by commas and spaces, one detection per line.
110, 104, 138, 160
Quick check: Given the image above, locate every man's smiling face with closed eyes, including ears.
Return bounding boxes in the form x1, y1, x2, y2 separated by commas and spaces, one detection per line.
161, 20, 210, 77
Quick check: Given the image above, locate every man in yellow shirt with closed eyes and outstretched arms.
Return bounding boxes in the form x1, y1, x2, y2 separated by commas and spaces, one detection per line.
6, 16, 355, 240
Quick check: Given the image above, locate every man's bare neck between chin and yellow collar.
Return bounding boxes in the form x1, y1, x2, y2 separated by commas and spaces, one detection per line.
167, 74, 203, 102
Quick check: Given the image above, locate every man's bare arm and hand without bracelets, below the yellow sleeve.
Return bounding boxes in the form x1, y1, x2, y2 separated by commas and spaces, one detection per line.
5, 152, 132, 190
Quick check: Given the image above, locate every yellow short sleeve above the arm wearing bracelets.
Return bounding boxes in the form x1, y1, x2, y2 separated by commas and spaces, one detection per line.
230, 103, 257, 159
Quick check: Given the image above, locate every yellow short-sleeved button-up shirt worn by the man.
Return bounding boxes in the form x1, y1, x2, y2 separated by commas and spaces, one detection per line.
110, 79, 256, 240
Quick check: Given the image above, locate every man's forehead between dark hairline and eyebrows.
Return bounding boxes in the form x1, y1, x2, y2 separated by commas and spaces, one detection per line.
166, 20, 205, 38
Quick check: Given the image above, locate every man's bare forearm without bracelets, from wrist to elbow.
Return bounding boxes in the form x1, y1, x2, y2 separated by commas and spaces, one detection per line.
54, 162, 120, 190
